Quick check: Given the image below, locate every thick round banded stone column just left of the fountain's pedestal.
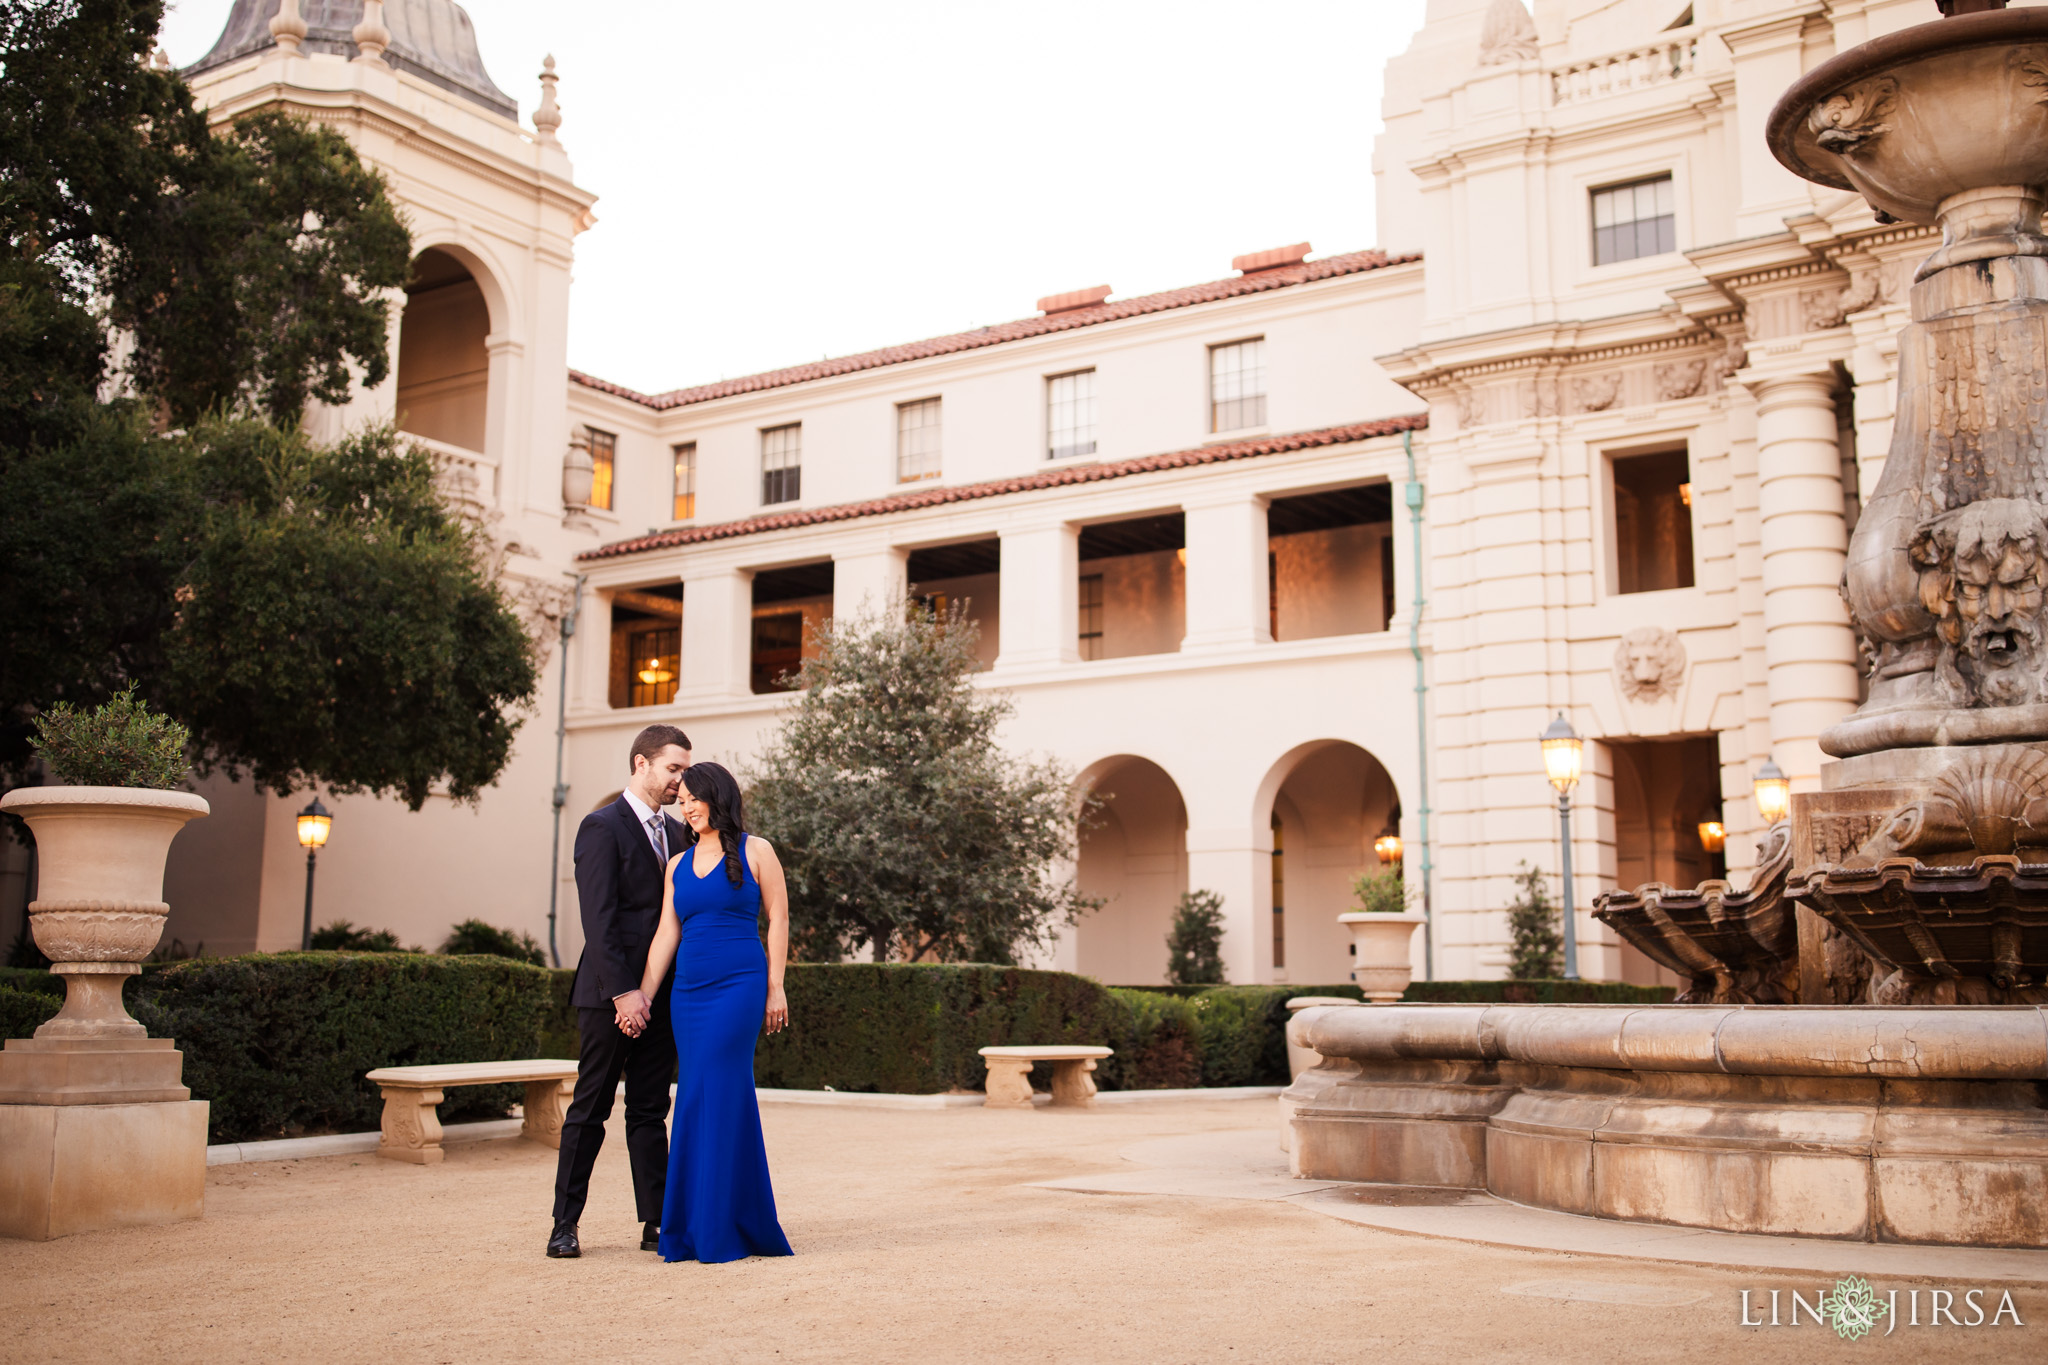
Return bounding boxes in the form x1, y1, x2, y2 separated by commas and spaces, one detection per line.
1745, 372, 1858, 792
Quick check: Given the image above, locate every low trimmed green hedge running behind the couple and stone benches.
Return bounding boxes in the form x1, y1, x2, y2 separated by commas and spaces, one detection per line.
0, 952, 1671, 1142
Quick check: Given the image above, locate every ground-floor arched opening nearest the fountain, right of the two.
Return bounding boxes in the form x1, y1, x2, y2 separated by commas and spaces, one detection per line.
1266, 739, 1401, 984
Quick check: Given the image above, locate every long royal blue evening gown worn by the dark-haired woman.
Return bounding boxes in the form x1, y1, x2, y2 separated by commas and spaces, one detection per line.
659, 835, 793, 1261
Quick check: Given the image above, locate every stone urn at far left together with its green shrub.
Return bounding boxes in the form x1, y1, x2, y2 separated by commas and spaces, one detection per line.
0, 690, 207, 1038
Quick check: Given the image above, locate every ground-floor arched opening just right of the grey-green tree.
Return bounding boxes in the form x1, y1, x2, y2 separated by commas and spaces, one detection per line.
1075, 755, 1188, 986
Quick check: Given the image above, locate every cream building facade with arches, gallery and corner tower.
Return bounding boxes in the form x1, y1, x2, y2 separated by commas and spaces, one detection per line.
4, 0, 1933, 982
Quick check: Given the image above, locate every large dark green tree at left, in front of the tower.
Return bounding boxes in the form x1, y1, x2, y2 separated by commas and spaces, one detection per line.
0, 0, 535, 806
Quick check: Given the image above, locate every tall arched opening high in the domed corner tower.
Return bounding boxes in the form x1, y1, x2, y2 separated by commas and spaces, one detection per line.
397, 248, 492, 452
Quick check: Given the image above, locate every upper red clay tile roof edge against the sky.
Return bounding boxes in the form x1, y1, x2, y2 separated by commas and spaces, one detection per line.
569, 250, 1421, 411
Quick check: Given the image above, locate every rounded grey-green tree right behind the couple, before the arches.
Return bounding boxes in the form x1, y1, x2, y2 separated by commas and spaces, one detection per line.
748, 606, 1096, 962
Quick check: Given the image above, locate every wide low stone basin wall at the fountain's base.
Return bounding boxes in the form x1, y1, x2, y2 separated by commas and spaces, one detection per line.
1282, 1005, 2048, 1246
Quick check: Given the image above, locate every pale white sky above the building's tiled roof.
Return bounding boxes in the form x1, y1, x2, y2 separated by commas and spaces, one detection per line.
162, 0, 1425, 391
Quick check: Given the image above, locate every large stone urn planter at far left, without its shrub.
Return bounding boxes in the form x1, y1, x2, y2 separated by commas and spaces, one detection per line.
0, 786, 207, 1040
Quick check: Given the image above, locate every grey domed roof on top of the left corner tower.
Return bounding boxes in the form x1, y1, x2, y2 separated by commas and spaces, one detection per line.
184, 0, 518, 121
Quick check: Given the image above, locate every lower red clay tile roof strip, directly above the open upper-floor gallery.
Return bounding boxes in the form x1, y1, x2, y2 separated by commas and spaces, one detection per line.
575, 413, 1430, 563
